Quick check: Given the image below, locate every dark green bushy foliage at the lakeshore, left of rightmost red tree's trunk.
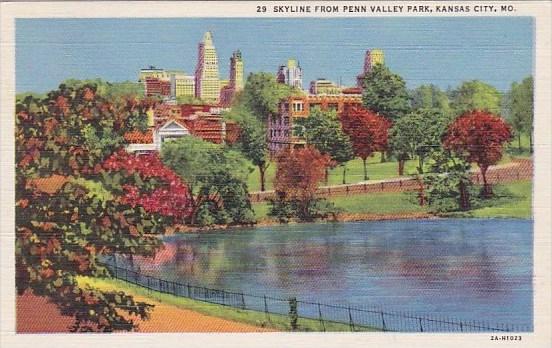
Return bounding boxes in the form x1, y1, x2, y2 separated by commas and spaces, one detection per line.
418, 150, 473, 213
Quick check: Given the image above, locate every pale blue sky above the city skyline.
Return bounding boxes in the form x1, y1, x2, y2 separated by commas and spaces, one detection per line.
16, 17, 534, 93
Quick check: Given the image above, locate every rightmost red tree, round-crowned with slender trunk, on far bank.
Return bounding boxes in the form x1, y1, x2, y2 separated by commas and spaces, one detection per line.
443, 110, 512, 197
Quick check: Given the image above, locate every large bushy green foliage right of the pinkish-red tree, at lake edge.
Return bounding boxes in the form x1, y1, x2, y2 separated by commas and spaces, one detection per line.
161, 136, 254, 225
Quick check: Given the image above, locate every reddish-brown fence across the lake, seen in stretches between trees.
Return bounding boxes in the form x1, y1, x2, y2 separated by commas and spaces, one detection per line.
249, 160, 533, 203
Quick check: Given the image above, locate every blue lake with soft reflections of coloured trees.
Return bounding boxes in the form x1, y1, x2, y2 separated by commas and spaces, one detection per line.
121, 219, 533, 328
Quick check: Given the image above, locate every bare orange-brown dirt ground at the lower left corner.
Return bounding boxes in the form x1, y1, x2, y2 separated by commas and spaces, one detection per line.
17, 293, 268, 333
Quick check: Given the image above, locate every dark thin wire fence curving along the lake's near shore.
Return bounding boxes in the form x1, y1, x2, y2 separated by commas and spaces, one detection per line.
100, 264, 531, 332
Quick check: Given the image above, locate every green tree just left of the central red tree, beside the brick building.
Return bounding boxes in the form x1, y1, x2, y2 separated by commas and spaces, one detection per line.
298, 108, 354, 184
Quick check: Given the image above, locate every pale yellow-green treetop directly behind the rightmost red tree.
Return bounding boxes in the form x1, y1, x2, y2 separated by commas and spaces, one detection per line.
451, 80, 501, 115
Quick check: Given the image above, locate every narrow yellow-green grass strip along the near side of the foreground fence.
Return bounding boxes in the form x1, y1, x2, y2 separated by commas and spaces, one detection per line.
78, 277, 378, 331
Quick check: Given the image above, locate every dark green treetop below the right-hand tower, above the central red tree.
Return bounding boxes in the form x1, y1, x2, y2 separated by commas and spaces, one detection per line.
362, 64, 410, 121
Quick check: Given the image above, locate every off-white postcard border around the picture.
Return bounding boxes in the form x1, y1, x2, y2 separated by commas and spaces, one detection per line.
0, 1, 552, 348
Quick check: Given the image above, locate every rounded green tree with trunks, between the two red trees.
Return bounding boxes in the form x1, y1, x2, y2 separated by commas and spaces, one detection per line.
389, 109, 448, 175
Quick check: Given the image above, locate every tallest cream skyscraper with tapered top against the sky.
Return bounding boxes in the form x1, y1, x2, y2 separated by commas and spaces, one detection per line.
195, 31, 220, 103
